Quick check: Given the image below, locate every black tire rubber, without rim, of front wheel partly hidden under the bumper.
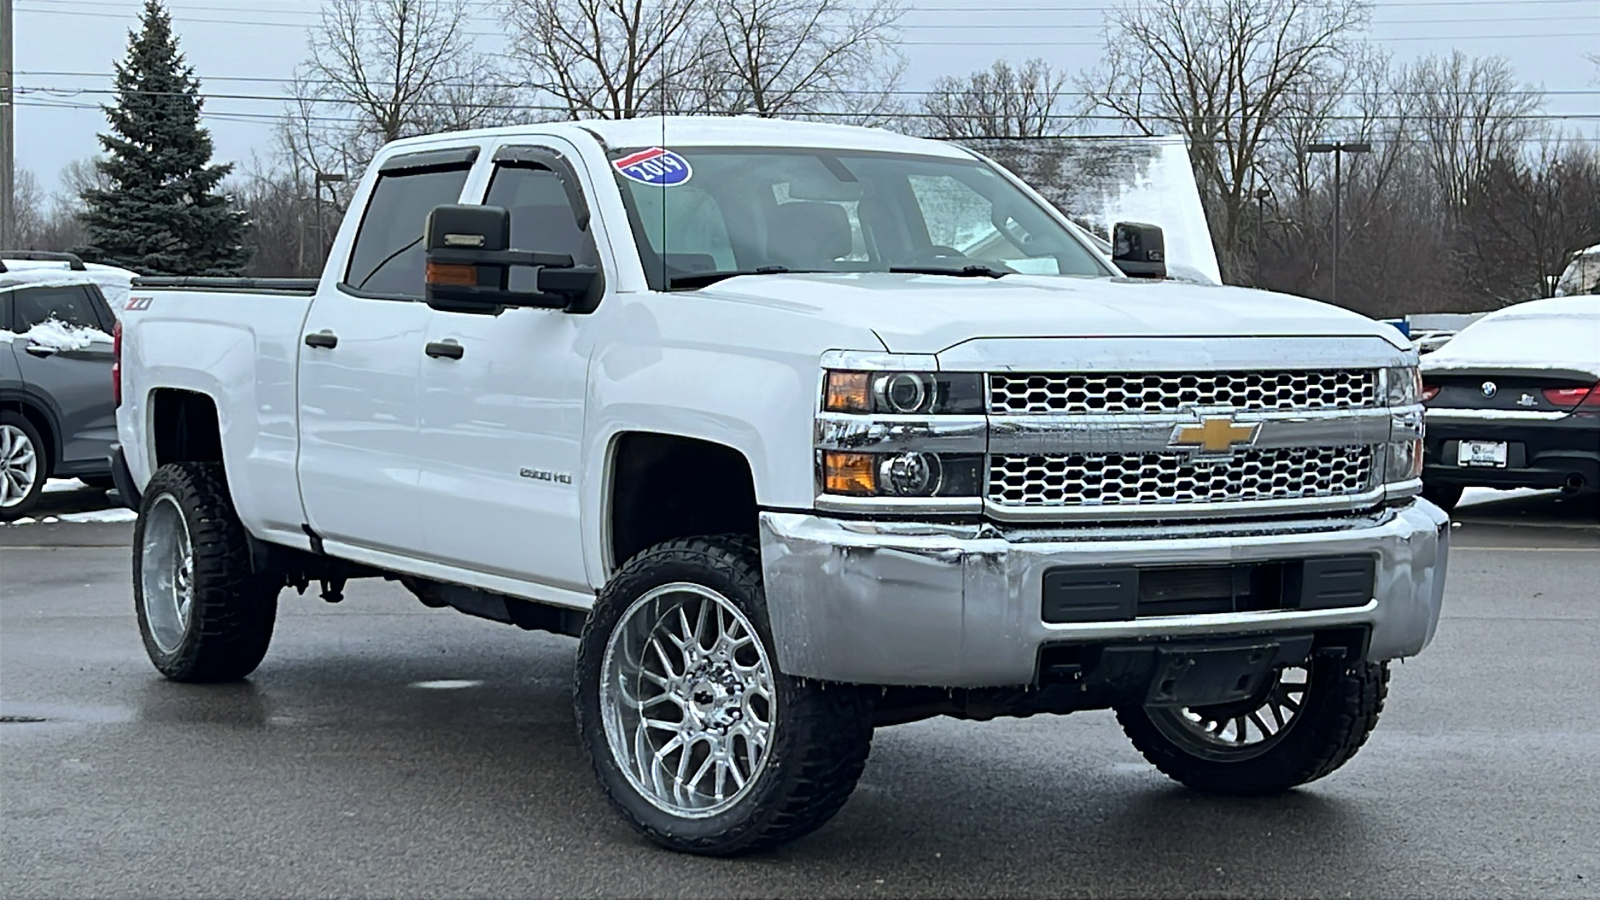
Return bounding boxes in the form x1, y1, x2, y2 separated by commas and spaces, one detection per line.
1117, 658, 1389, 796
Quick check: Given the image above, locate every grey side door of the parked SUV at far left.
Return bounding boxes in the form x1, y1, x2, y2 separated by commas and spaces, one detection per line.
8, 285, 117, 476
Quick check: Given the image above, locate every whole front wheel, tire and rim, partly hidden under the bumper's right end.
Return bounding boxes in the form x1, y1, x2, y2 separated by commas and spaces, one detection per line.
1117, 658, 1389, 796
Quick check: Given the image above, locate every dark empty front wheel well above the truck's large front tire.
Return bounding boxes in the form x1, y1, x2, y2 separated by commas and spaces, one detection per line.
611, 434, 757, 567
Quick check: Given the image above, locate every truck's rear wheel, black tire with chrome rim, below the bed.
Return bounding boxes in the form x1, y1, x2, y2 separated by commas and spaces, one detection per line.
133, 463, 282, 682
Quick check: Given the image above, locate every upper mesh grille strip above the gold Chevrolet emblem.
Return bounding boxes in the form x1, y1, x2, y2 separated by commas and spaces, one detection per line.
989, 368, 1378, 415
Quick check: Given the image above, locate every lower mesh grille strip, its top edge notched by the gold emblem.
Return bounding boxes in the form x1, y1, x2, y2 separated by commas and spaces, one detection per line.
989, 447, 1374, 508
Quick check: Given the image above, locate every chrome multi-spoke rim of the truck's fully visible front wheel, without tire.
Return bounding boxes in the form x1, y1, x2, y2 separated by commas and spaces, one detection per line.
600, 583, 778, 818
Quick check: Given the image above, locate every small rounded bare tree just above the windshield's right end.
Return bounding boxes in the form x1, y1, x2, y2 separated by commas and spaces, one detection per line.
918, 58, 1070, 138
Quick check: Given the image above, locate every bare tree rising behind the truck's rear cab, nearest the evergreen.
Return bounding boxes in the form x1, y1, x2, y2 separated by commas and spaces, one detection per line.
280, 0, 518, 171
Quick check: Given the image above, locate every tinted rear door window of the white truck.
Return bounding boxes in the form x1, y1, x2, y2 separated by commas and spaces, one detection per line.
344, 167, 470, 299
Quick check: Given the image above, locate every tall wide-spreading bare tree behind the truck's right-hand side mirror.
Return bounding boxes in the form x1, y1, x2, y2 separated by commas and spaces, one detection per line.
1083, 0, 1370, 277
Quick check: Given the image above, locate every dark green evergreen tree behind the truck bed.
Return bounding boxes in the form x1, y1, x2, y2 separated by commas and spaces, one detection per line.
82, 0, 250, 275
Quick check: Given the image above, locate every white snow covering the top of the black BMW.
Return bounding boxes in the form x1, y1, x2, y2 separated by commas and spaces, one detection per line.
1422, 296, 1600, 378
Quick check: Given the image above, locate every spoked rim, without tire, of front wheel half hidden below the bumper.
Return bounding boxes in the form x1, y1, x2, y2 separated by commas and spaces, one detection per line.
1149, 666, 1310, 762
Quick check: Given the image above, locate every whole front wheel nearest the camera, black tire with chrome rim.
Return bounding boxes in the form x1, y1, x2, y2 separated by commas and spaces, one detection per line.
574, 536, 872, 855
